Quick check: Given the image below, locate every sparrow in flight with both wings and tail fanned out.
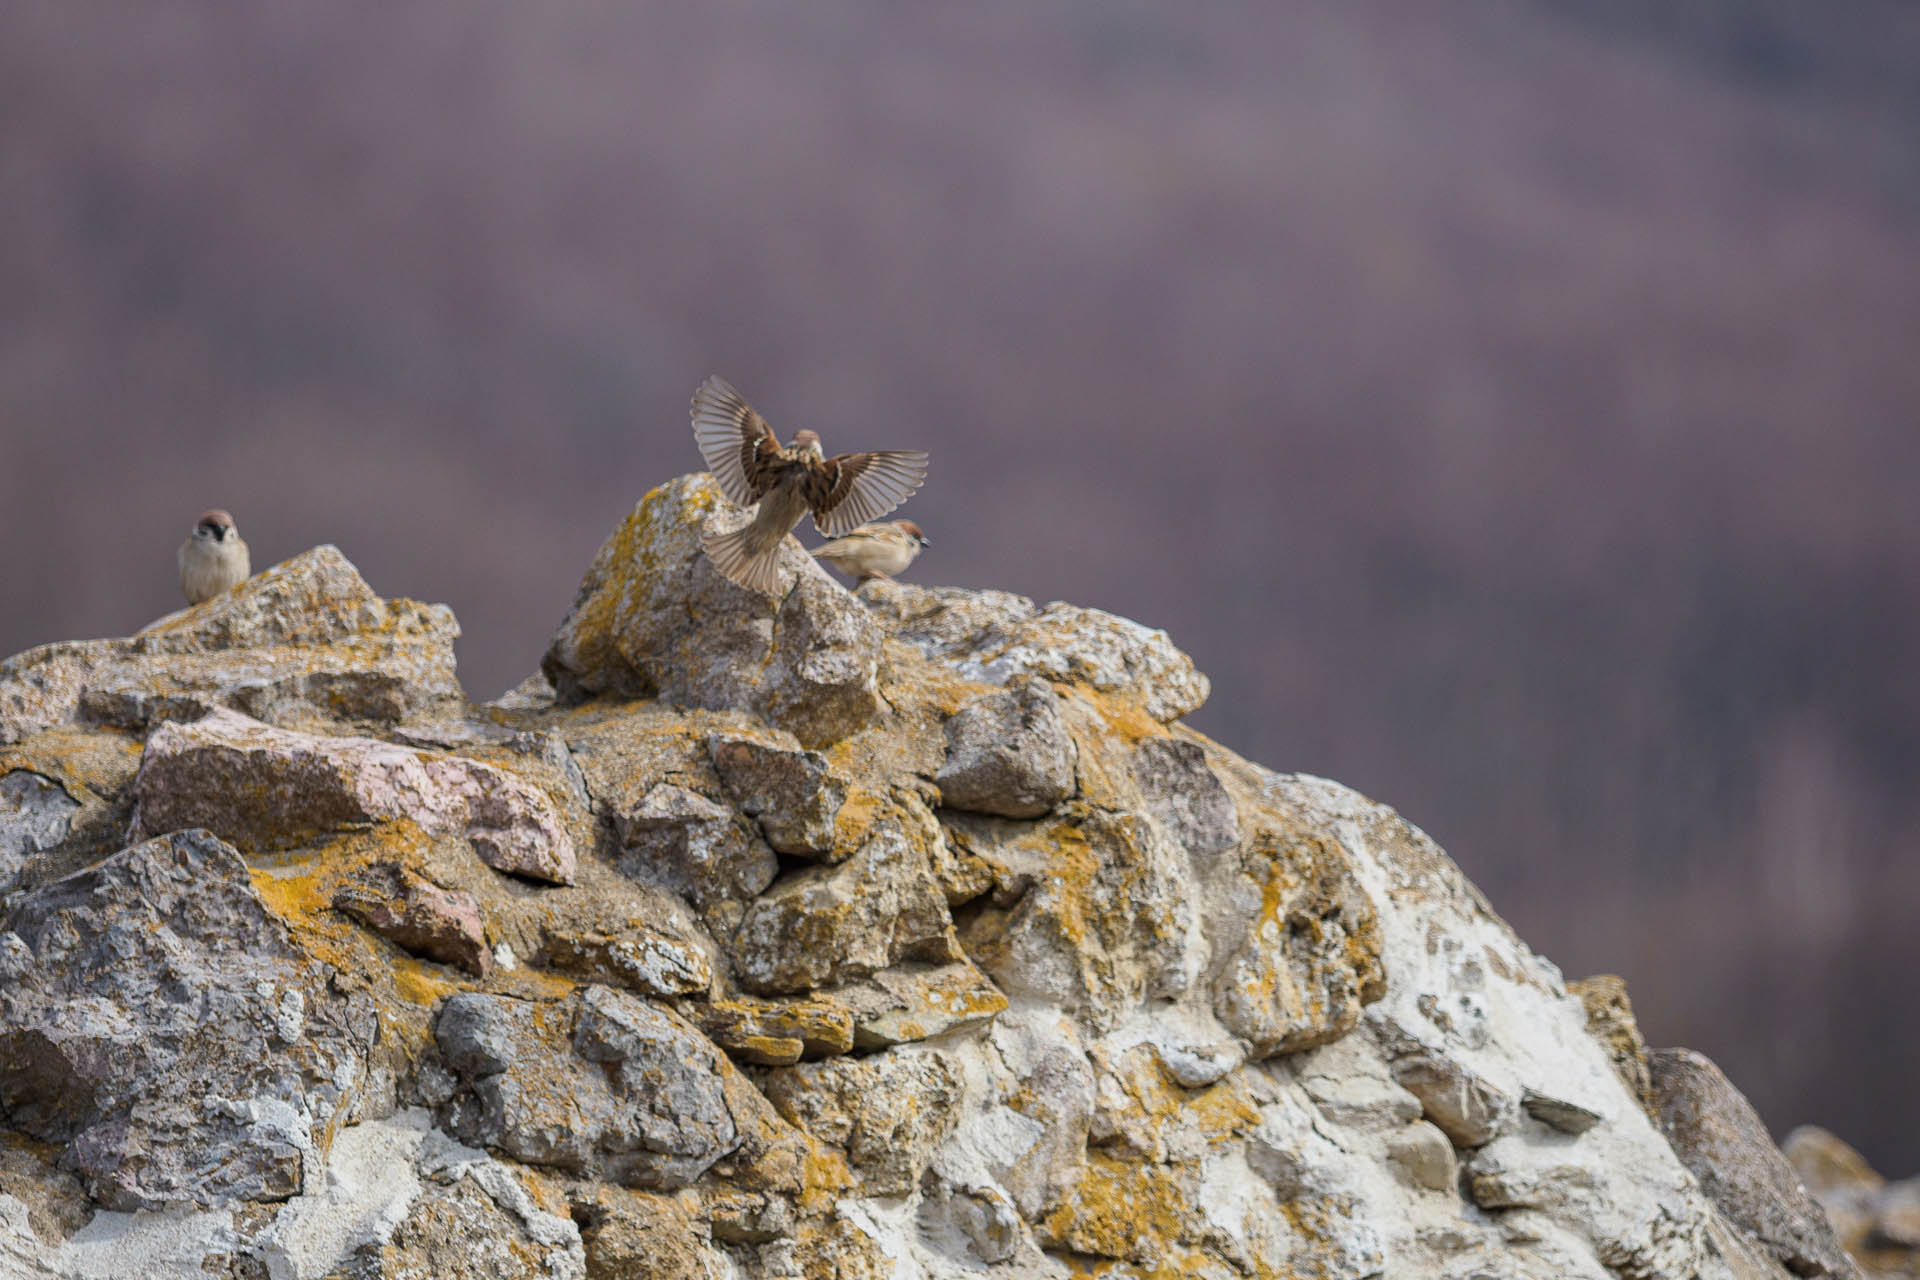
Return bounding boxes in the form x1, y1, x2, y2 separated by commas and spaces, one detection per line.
693, 368, 927, 595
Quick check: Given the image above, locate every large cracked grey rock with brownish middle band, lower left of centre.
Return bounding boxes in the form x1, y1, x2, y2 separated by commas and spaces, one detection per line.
434, 986, 741, 1190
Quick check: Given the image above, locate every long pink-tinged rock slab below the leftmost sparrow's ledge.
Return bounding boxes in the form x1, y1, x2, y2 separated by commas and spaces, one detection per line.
132, 710, 574, 885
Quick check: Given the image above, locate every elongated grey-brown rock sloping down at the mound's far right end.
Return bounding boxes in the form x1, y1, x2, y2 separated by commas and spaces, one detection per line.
1649, 1050, 1860, 1280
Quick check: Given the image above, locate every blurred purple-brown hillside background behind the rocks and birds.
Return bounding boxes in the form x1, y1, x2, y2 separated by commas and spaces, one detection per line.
0, 0, 1920, 1173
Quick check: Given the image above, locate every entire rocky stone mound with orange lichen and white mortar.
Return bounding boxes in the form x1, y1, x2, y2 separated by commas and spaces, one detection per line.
0, 476, 1866, 1280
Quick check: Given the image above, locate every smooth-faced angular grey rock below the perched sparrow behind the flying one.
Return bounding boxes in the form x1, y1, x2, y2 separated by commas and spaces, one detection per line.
933, 679, 1073, 818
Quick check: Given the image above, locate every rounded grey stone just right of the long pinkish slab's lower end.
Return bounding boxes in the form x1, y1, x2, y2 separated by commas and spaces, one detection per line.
612, 783, 780, 912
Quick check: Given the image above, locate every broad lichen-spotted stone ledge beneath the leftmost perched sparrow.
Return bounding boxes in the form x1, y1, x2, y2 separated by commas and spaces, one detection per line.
0, 547, 459, 743
